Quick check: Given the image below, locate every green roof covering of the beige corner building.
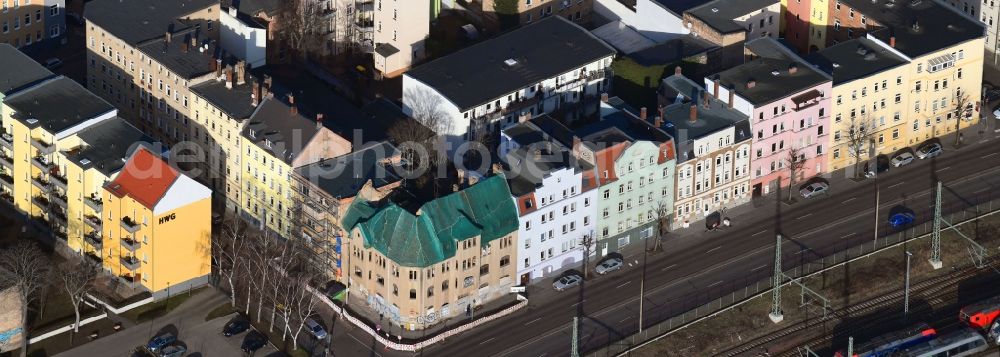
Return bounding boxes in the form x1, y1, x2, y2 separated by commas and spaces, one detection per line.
342, 175, 517, 268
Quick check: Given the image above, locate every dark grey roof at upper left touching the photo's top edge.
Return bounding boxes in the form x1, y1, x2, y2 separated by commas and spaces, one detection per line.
83, 0, 219, 45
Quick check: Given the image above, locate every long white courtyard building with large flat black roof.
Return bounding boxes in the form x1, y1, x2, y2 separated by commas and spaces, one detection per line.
403, 16, 616, 147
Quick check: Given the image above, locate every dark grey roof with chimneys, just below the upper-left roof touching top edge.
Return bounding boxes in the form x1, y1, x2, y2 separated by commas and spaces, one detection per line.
138, 28, 219, 79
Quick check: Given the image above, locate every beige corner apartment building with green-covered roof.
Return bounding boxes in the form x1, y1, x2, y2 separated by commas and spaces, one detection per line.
342, 174, 518, 330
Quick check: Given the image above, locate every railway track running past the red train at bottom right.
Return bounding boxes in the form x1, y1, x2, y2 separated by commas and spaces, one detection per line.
716, 259, 993, 356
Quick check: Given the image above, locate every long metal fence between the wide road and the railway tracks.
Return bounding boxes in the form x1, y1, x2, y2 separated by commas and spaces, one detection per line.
581, 188, 1000, 356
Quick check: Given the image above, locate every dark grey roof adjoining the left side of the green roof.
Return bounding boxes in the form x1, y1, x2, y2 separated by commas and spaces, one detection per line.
295, 142, 402, 198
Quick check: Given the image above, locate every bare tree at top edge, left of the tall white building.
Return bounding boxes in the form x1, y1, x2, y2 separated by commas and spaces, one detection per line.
276, 0, 329, 58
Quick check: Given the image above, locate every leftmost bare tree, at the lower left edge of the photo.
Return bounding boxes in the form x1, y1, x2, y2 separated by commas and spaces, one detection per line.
0, 240, 50, 357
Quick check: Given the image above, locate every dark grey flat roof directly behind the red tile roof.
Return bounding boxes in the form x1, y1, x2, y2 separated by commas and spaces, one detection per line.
66, 117, 153, 176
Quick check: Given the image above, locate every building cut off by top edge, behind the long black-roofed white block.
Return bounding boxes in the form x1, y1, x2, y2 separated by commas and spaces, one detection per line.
472, 0, 594, 30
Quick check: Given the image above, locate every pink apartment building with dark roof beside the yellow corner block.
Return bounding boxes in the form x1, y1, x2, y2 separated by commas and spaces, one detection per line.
705, 38, 832, 196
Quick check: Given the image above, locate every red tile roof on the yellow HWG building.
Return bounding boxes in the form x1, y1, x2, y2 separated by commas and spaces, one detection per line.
104, 148, 180, 209
